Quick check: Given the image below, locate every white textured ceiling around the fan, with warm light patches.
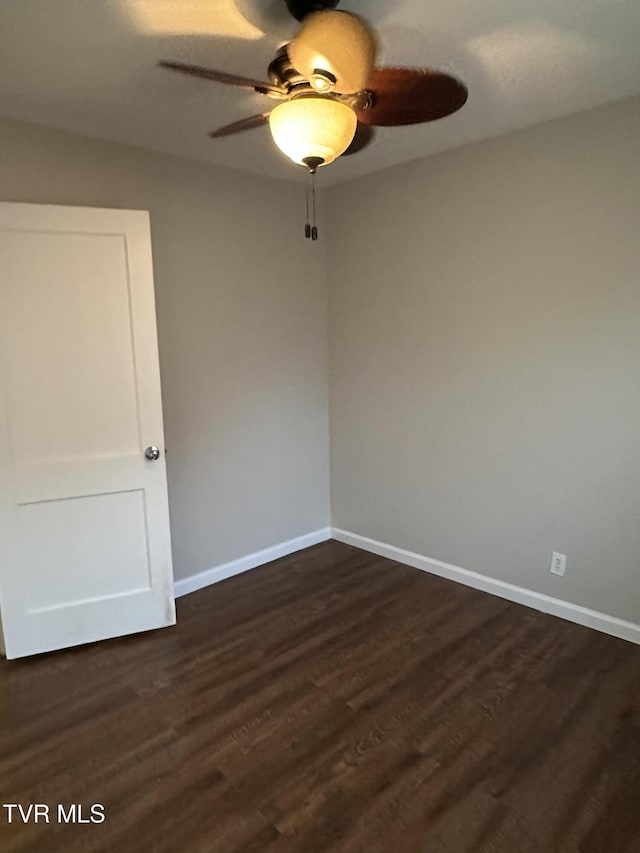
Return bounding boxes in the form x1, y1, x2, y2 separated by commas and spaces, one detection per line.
0, 0, 640, 184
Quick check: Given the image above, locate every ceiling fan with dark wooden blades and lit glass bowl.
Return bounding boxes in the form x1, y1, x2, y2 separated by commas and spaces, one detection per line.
159, 0, 468, 174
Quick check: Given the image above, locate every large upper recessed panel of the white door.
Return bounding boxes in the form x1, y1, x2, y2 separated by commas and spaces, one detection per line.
0, 232, 140, 465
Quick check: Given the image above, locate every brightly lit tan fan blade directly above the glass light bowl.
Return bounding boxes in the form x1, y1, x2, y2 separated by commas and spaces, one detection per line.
288, 10, 376, 94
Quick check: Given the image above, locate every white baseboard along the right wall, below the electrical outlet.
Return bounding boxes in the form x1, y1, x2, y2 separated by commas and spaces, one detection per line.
331, 527, 640, 645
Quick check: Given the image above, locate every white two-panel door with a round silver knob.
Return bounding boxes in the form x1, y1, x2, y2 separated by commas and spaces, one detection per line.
0, 203, 175, 658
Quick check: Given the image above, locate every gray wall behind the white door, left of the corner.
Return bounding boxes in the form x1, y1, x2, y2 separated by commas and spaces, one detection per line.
0, 115, 329, 578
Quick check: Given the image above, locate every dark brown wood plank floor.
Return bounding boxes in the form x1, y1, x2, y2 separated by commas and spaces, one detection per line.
0, 542, 640, 853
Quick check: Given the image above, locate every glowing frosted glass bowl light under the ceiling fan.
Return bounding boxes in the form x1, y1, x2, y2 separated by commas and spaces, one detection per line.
269, 95, 358, 166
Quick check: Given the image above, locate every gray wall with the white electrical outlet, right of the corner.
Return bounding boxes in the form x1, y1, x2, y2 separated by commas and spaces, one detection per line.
326, 100, 640, 622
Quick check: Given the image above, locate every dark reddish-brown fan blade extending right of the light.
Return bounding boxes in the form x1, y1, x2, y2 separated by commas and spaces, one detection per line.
358, 68, 469, 127
